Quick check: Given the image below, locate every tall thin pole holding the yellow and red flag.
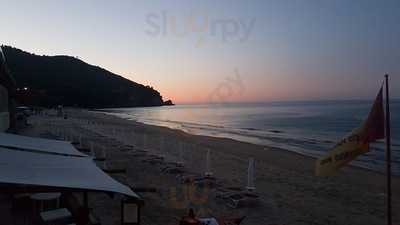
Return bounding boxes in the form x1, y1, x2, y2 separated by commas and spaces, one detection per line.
385, 74, 392, 225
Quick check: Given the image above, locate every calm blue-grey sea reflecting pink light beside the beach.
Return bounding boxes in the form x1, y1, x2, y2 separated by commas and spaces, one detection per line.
102, 100, 400, 175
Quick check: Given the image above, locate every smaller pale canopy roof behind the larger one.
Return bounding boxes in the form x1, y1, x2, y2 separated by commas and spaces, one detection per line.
0, 133, 87, 157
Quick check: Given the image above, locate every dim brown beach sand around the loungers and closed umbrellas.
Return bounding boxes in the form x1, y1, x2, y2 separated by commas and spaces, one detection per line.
21, 109, 400, 225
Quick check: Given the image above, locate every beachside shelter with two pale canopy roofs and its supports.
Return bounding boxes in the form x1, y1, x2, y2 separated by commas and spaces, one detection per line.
0, 133, 143, 225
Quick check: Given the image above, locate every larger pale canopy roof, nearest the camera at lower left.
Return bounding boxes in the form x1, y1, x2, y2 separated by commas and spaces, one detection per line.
0, 147, 139, 198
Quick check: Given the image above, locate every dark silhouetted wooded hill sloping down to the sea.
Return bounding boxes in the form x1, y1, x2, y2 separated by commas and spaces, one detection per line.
2, 46, 172, 108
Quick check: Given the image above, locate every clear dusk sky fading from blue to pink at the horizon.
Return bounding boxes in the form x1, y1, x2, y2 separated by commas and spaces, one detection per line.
0, 0, 400, 103
